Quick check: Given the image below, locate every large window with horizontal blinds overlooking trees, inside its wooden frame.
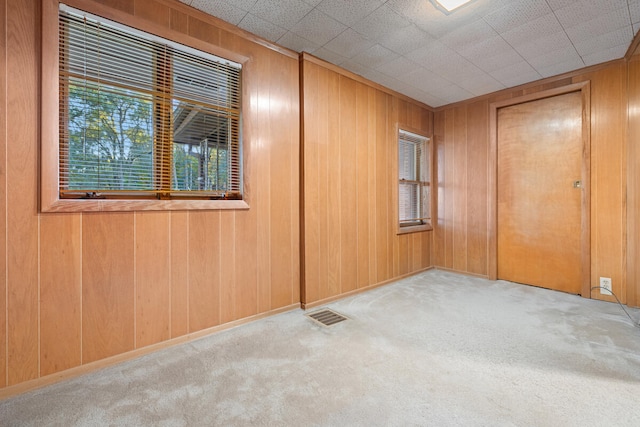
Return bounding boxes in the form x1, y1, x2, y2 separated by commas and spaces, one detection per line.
59, 5, 242, 199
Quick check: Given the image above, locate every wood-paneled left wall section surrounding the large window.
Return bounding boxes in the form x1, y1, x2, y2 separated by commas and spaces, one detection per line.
0, 0, 300, 387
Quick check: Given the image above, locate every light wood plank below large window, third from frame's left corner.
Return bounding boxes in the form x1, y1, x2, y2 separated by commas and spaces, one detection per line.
135, 212, 171, 348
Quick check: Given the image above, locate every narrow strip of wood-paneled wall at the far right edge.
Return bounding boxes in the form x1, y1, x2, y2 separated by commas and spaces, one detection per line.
627, 45, 640, 306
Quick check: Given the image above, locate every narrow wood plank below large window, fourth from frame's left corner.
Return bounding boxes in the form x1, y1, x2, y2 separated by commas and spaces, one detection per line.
171, 212, 189, 338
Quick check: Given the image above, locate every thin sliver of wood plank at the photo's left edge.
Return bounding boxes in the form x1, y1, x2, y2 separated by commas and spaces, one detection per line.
0, 0, 7, 387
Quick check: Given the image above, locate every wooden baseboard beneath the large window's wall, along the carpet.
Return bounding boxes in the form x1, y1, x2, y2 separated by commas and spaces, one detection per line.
0, 303, 300, 400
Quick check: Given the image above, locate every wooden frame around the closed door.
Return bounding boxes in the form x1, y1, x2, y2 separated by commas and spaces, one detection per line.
487, 80, 591, 298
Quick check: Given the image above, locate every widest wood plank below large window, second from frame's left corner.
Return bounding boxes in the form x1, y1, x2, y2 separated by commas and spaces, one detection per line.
82, 213, 135, 363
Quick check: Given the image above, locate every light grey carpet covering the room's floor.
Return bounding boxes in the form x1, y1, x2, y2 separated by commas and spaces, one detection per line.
0, 270, 640, 426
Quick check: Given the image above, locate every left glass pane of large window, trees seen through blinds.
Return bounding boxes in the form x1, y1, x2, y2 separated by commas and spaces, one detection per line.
61, 79, 153, 191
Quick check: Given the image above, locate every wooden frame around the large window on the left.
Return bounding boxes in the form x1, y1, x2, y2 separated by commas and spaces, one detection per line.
40, 0, 250, 212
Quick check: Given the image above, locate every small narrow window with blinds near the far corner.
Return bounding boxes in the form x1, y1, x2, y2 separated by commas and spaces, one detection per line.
398, 129, 431, 227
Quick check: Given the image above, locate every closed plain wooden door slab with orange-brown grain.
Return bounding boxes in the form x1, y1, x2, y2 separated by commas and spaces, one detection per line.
497, 92, 588, 294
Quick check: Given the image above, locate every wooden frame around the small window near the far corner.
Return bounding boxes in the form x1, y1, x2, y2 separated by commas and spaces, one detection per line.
394, 124, 434, 235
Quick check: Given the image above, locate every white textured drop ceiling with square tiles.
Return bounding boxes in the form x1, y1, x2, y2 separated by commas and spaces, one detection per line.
180, 0, 640, 107
